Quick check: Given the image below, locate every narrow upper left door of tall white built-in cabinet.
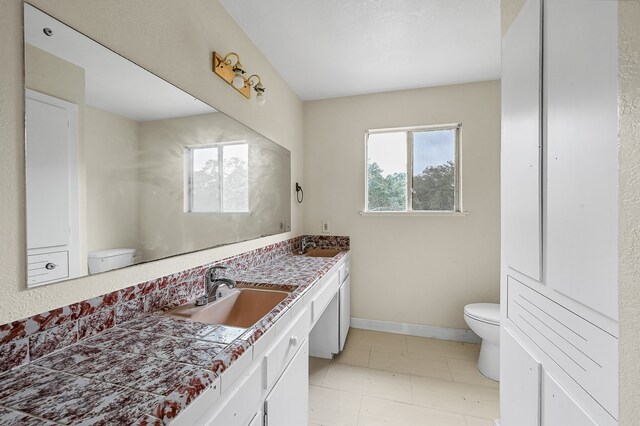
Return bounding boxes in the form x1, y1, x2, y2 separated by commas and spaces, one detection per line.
501, 0, 542, 281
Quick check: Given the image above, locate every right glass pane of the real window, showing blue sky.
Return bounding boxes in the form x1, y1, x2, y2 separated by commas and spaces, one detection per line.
411, 129, 456, 210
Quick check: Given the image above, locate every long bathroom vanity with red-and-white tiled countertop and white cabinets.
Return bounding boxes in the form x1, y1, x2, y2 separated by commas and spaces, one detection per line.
0, 236, 350, 426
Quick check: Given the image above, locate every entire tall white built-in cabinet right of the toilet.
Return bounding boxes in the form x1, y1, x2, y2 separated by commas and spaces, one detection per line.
500, 0, 618, 426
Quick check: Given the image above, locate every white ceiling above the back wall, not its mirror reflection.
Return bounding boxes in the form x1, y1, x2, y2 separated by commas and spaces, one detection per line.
220, 0, 500, 100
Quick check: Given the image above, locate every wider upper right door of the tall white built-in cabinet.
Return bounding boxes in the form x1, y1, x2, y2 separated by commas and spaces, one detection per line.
543, 0, 618, 319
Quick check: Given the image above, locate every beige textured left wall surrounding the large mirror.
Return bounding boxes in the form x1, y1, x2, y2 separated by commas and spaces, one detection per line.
0, 0, 303, 324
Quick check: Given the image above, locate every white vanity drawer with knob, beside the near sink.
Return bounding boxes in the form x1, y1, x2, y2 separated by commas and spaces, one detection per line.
263, 309, 309, 389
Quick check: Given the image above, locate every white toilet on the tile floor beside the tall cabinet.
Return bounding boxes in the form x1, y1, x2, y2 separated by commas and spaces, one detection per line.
464, 303, 500, 382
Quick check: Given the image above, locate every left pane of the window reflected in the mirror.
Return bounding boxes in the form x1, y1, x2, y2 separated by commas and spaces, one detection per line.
191, 147, 220, 212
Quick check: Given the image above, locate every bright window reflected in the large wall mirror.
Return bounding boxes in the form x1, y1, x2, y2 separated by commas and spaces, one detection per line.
185, 142, 249, 213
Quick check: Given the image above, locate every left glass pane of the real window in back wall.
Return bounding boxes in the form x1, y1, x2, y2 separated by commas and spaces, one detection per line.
367, 132, 407, 211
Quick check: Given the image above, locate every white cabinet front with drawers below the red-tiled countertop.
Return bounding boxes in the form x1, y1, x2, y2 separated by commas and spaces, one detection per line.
172, 255, 349, 426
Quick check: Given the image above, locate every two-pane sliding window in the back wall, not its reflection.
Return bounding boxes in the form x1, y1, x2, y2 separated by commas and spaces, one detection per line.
366, 124, 461, 212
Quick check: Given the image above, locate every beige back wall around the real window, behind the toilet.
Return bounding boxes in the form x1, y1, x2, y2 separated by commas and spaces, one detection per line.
304, 81, 500, 328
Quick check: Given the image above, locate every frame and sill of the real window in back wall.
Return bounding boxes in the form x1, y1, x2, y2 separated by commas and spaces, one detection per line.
360, 122, 467, 216
